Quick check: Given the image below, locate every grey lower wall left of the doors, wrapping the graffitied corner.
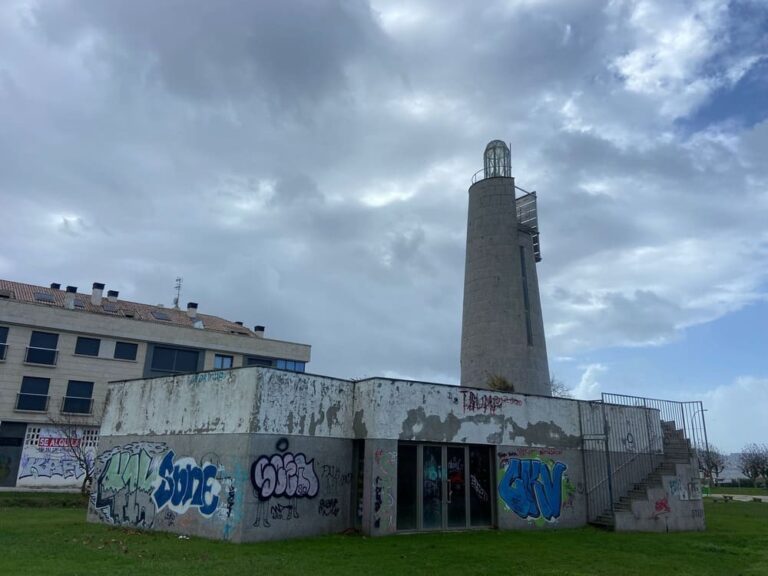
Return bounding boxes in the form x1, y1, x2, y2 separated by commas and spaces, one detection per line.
88, 434, 352, 541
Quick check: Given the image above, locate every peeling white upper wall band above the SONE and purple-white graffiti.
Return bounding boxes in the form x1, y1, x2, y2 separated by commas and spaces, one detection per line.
102, 368, 354, 438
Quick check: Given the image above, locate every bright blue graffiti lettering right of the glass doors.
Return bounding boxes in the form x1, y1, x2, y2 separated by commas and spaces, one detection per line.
499, 456, 576, 522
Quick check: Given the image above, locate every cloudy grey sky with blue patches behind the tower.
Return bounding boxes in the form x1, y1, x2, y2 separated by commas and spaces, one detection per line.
0, 0, 768, 451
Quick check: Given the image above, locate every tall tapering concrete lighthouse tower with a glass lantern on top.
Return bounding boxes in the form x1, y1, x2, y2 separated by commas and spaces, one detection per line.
461, 140, 551, 396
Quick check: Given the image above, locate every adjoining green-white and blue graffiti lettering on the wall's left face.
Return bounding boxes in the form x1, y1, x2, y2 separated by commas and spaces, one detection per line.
91, 442, 226, 528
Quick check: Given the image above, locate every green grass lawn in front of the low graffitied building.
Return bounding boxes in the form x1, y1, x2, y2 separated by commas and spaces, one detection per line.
0, 493, 768, 576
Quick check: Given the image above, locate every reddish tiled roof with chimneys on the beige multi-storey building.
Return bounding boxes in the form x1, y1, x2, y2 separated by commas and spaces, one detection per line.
0, 279, 257, 338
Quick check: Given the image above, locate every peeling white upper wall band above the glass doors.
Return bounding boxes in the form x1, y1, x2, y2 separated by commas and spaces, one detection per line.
354, 378, 581, 448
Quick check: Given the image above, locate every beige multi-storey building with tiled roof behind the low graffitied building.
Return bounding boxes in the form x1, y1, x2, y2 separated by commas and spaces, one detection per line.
0, 280, 310, 487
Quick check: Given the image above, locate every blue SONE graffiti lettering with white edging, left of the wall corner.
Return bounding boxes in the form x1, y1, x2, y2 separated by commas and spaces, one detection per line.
152, 450, 221, 516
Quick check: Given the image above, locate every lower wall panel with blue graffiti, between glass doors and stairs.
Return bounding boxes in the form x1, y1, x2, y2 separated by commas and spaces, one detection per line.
496, 446, 587, 529
